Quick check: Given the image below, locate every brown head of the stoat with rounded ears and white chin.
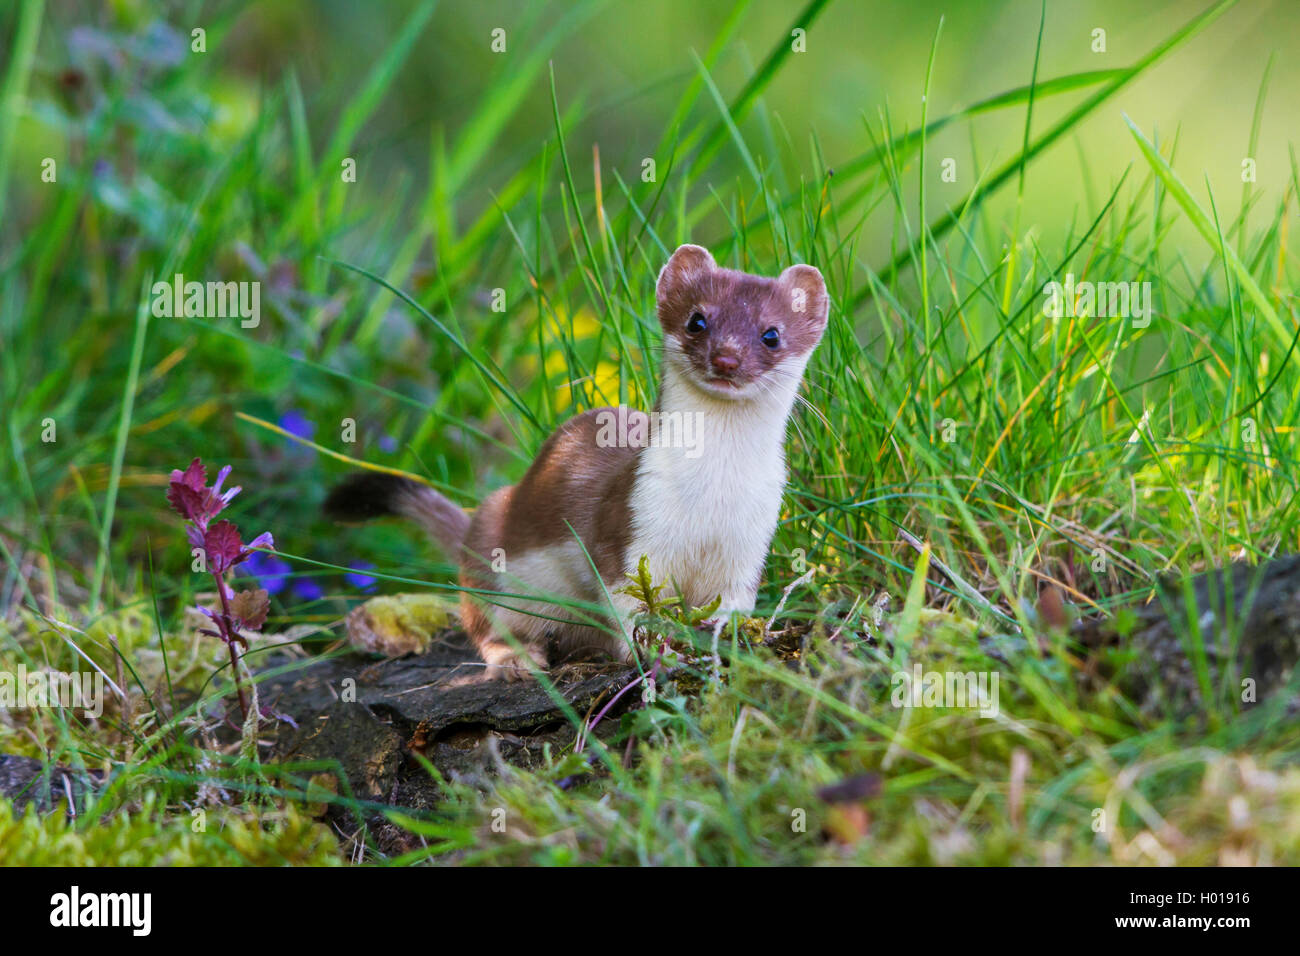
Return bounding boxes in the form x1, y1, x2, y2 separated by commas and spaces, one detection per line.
655, 246, 829, 399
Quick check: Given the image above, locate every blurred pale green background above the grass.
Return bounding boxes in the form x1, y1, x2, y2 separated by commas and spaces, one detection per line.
10, 0, 1300, 252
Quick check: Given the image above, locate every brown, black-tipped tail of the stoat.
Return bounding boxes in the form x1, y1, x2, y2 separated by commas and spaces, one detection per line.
325, 471, 469, 559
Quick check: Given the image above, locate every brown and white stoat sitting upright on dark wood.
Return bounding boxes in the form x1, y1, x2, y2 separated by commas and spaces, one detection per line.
325, 245, 828, 679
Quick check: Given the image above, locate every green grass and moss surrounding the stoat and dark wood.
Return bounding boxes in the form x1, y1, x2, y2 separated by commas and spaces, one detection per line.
0, 0, 1300, 864
